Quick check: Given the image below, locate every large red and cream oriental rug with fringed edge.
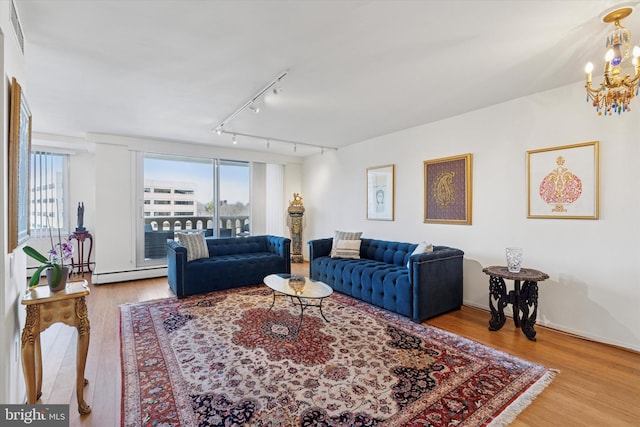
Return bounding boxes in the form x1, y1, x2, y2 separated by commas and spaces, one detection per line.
120, 287, 554, 426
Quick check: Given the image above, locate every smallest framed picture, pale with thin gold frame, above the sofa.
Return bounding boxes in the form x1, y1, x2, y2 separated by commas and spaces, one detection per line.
367, 165, 395, 221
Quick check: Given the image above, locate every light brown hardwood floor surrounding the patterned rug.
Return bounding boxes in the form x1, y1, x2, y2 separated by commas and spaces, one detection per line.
36, 263, 640, 427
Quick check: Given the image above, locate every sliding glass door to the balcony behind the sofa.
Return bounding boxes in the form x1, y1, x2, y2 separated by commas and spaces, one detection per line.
136, 153, 251, 266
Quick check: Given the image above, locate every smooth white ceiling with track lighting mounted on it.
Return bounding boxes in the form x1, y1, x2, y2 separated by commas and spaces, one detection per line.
14, 0, 640, 156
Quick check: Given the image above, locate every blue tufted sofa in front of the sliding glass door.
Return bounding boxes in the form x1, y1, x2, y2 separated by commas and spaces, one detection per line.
167, 235, 291, 297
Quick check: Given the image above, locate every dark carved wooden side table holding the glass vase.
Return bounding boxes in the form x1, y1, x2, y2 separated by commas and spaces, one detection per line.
482, 266, 549, 341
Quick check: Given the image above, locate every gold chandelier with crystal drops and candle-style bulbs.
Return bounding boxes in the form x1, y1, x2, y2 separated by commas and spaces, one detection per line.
584, 7, 640, 116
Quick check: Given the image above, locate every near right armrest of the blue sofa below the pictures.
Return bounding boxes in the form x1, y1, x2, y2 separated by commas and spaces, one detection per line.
409, 246, 464, 321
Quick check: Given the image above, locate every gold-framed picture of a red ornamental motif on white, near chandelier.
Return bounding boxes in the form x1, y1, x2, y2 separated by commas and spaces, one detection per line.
527, 141, 600, 219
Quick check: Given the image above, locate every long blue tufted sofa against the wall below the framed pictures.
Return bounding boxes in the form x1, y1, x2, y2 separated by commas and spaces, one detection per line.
309, 238, 464, 322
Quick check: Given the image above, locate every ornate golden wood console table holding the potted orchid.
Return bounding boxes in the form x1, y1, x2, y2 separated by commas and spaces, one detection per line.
22, 280, 91, 414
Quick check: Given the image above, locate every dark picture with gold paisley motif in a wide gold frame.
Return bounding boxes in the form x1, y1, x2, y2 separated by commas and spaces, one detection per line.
424, 153, 472, 224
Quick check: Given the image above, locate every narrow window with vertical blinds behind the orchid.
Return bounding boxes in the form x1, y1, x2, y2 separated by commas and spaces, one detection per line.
29, 151, 69, 237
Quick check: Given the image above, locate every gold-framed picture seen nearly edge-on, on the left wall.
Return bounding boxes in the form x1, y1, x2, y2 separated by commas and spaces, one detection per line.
8, 77, 31, 252
